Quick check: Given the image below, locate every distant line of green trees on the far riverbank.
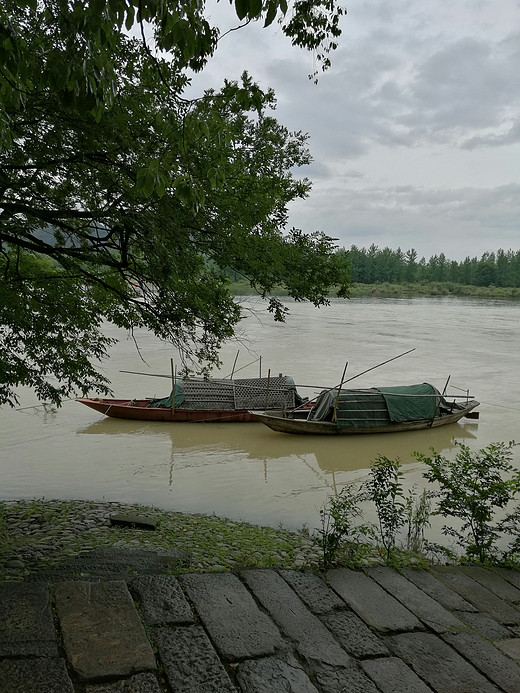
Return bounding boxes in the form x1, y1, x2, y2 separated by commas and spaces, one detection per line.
339, 244, 520, 287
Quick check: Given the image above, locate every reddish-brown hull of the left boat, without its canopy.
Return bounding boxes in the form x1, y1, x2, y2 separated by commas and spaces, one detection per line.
76, 397, 257, 423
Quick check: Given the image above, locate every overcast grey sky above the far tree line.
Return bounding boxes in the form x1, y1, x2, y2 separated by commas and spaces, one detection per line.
188, 0, 520, 260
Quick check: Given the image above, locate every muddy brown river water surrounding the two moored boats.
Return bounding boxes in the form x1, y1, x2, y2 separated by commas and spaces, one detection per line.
0, 297, 520, 530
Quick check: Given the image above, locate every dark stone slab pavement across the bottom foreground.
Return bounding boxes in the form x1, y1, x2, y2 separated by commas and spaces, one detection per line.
0, 556, 520, 693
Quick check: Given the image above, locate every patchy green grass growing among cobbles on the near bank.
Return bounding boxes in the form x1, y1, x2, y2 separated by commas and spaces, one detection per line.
0, 501, 318, 579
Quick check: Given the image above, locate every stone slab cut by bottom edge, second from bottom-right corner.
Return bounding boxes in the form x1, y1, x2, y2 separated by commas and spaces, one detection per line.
386, 633, 499, 693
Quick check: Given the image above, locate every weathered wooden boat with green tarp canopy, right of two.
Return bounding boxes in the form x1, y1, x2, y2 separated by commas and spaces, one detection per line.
251, 383, 479, 435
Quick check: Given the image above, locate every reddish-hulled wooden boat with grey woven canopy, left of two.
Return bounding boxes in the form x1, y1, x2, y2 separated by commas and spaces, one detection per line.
76, 375, 302, 422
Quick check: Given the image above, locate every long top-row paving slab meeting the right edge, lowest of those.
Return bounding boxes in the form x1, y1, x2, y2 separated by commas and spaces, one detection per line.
433, 566, 520, 626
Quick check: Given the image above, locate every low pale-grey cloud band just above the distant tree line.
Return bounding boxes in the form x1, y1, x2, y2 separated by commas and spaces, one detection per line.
291, 184, 520, 259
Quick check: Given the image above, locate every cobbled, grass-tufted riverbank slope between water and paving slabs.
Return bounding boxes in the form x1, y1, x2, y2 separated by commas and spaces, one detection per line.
0, 500, 321, 582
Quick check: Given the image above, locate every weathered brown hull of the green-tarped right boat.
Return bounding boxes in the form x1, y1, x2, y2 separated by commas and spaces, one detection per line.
251, 400, 480, 436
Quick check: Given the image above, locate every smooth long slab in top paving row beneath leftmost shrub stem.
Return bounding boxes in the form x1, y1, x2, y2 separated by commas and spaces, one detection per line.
325, 568, 424, 633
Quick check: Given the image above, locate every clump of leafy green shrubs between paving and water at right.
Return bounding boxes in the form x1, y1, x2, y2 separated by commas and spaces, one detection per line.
321, 441, 520, 567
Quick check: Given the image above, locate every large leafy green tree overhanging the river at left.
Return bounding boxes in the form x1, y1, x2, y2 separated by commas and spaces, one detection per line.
0, 0, 349, 405
